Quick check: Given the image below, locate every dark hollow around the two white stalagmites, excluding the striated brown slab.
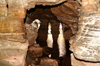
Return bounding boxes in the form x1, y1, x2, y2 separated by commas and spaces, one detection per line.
26, 6, 72, 66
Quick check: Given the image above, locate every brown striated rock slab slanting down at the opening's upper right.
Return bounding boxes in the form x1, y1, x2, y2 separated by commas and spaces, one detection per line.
51, 1, 80, 34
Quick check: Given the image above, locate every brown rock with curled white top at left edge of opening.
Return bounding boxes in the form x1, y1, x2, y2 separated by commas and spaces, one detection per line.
25, 19, 41, 46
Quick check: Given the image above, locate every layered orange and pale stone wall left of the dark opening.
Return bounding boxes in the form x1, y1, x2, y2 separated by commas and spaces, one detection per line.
0, 0, 28, 66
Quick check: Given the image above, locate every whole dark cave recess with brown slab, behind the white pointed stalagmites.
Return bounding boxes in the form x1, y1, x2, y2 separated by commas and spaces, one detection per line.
25, 2, 79, 66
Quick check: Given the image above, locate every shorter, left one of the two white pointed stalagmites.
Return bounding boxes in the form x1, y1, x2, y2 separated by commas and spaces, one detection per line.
47, 23, 53, 57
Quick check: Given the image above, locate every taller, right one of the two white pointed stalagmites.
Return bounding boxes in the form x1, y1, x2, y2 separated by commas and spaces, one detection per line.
57, 23, 66, 57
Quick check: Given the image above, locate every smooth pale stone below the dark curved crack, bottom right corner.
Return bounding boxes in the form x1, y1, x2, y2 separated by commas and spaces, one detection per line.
71, 53, 100, 66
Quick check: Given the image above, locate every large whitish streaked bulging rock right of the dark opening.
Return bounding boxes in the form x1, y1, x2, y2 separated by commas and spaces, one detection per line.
70, 0, 100, 62
